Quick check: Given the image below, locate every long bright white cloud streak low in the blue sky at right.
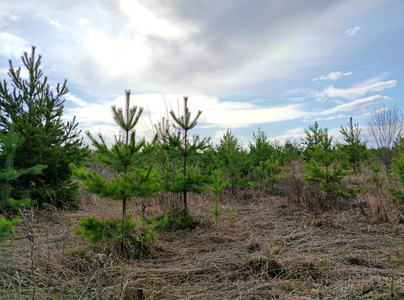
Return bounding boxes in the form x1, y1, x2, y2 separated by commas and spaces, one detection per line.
324, 80, 397, 100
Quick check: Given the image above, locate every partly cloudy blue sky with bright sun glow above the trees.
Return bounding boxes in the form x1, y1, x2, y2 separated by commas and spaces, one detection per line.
0, 0, 404, 146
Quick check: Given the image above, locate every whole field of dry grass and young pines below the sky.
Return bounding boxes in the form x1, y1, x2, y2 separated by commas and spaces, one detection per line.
0, 50, 404, 299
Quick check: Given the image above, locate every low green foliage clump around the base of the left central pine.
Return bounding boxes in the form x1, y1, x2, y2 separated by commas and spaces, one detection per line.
75, 214, 156, 257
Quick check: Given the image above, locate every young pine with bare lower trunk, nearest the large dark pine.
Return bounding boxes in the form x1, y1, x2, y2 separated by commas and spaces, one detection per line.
72, 91, 160, 247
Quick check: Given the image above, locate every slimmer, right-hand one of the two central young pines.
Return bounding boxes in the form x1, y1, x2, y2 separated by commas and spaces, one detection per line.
163, 97, 210, 216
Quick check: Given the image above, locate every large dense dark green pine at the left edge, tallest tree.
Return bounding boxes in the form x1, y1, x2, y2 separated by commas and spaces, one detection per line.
0, 47, 87, 207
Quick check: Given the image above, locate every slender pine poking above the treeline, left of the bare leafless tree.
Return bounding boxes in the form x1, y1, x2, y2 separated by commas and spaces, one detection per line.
338, 117, 369, 172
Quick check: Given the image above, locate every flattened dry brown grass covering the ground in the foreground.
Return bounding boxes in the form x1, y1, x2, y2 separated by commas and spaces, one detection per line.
0, 178, 404, 299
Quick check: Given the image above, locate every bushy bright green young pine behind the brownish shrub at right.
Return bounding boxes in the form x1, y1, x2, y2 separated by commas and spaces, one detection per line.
305, 123, 357, 208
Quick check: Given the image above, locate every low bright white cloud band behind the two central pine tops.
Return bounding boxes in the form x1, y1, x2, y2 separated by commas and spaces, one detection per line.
65, 94, 309, 141
